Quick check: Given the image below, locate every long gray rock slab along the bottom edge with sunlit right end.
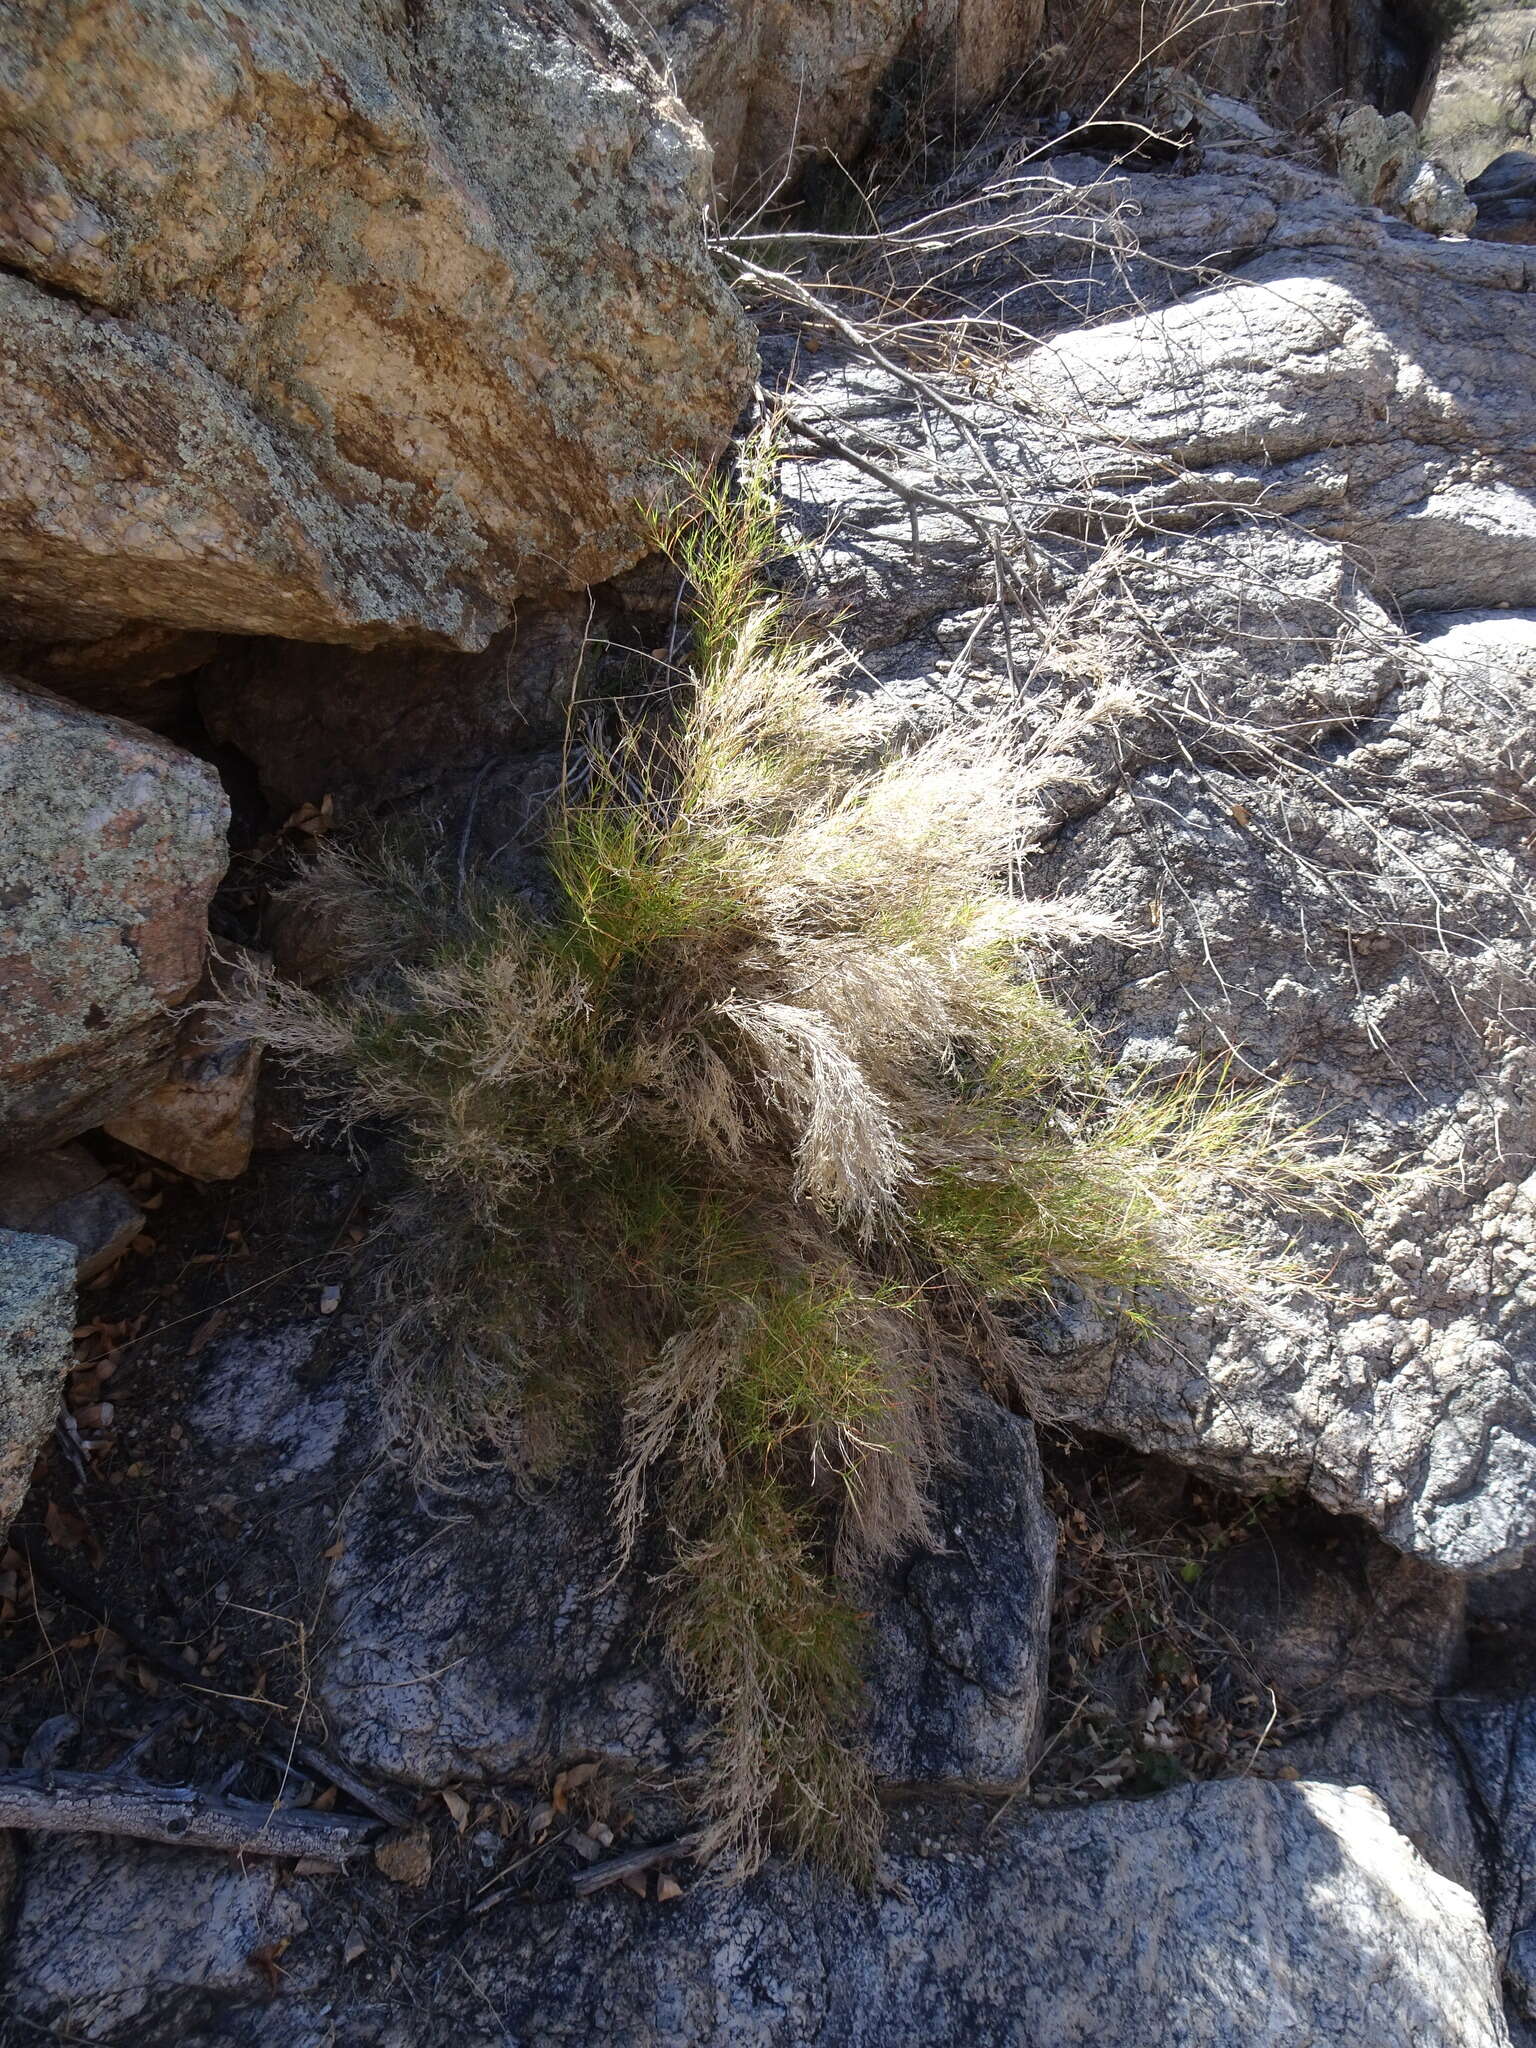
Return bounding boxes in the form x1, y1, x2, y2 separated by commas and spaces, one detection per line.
335, 1782, 1507, 2048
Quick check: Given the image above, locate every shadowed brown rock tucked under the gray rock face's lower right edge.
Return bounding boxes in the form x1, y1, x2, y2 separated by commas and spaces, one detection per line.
1194, 1518, 1466, 1712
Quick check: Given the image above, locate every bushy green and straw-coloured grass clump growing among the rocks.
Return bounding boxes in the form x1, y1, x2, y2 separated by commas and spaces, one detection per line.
246, 449, 1351, 1876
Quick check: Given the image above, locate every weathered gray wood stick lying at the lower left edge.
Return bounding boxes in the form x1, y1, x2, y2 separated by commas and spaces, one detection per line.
0, 1772, 379, 1864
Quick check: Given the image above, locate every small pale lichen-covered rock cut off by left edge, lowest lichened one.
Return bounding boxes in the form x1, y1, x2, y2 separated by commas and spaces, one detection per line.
0, 1231, 74, 1530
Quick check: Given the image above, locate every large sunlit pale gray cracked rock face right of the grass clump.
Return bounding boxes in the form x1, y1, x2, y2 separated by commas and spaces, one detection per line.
770, 150, 1536, 1571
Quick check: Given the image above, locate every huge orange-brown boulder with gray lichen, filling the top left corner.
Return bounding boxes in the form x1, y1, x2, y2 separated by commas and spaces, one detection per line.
0, 0, 752, 647
